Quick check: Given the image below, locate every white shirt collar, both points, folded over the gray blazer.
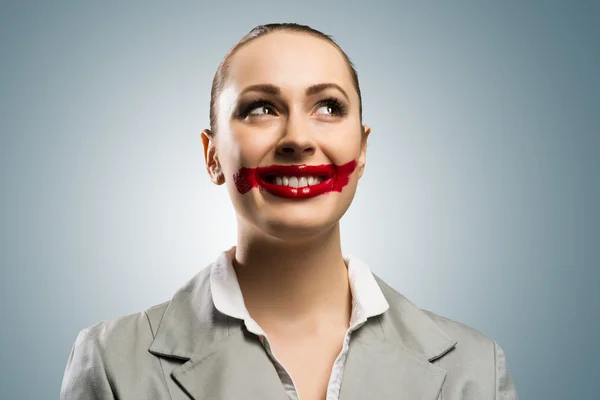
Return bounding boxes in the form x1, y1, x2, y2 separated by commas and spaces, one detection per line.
210, 246, 390, 336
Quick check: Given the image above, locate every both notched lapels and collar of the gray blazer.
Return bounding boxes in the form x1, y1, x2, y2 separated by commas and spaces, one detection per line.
149, 255, 457, 400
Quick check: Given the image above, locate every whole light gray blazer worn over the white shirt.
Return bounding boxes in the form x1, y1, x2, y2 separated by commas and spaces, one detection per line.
60, 268, 517, 400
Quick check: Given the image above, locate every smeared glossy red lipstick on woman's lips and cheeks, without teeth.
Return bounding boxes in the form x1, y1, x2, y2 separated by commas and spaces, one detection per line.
233, 160, 356, 199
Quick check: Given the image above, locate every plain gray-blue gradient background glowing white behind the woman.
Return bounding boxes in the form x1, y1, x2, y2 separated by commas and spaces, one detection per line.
0, 0, 600, 400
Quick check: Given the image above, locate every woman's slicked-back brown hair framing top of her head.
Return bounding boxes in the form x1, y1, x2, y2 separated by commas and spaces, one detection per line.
210, 23, 364, 135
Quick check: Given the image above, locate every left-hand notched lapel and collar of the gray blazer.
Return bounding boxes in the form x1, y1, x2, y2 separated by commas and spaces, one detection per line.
148, 267, 287, 400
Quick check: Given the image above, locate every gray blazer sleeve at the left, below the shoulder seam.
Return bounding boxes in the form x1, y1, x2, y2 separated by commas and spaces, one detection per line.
60, 329, 116, 400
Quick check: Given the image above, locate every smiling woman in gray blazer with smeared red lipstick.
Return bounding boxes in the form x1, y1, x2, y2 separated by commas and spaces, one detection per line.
61, 24, 517, 400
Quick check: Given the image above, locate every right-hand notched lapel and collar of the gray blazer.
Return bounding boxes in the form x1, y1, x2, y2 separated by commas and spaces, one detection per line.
340, 275, 458, 400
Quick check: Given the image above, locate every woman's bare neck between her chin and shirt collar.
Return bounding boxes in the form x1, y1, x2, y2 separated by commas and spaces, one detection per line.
234, 224, 352, 334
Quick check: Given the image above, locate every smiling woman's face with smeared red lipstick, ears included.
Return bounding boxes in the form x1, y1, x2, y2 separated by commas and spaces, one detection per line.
203, 32, 370, 241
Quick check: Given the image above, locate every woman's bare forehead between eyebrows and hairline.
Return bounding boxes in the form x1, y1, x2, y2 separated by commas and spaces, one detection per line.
230, 32, 352, 93
